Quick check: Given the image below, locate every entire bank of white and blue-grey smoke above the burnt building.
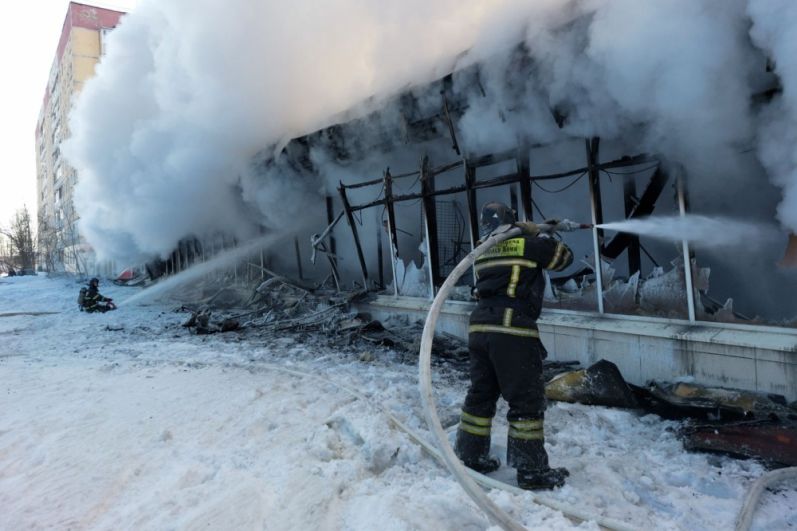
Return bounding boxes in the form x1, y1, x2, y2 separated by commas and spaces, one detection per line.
64, 0, 797, 264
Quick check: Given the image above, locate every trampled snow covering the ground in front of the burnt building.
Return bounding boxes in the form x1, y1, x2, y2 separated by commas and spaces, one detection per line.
0, 276, 797, 531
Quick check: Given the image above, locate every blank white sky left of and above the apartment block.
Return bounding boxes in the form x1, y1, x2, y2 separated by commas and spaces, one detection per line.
0, 0, 137, 227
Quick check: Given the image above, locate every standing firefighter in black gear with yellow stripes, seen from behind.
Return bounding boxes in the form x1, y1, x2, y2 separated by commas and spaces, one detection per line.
455, 203, 573, 489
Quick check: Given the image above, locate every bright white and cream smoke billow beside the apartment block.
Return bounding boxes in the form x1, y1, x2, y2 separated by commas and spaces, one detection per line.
64, 0, 510, 258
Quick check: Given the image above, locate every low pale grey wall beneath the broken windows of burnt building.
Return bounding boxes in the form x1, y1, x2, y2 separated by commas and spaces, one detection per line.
361, 296, 797, 400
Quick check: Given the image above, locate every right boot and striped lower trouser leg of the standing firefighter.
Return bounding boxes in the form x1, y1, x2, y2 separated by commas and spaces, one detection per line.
506, 419, 570, 490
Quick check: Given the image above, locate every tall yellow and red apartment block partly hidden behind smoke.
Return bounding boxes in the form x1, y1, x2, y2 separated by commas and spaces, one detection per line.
36, 2, 124, 272
